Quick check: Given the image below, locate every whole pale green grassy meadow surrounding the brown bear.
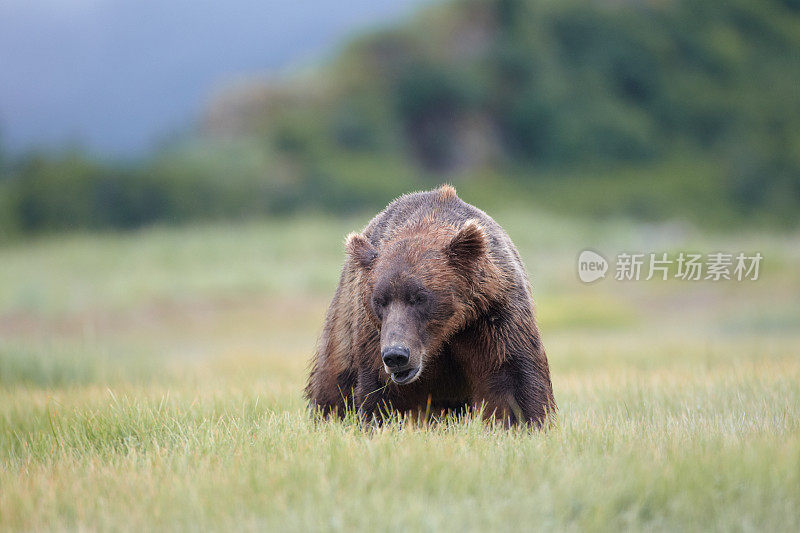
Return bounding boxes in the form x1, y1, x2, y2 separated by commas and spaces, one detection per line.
0, 212, 800, 531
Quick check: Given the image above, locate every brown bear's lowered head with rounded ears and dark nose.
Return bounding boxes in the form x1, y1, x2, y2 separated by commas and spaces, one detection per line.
346, 220, 493, 385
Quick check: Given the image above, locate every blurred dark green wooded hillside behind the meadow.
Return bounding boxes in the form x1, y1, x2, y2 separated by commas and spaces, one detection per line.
0, 0, 800, 237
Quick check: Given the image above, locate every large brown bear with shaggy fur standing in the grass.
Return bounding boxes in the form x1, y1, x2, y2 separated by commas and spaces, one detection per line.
305, 185, 556, 426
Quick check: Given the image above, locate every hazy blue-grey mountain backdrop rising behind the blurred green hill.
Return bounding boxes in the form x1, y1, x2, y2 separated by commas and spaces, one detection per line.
0, 0, 432, 155
